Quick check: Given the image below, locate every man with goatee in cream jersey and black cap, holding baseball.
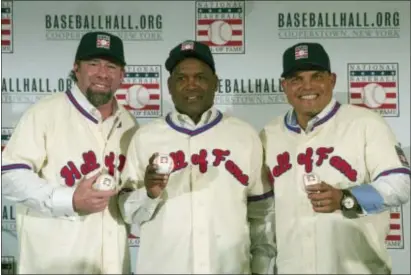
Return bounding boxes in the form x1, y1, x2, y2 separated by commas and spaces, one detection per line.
2, 32, 136, 274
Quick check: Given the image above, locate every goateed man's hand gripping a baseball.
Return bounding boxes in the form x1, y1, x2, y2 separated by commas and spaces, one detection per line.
73, 173, 117, 214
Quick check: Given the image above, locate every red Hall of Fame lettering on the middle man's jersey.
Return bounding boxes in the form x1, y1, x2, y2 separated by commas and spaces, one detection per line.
170, 149, 248, 186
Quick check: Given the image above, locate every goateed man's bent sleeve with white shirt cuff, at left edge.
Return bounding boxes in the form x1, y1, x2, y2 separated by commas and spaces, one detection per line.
1, 105, 78, 217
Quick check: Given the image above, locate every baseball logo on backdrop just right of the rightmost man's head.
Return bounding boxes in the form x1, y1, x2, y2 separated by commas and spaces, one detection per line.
348, 63, 399, 117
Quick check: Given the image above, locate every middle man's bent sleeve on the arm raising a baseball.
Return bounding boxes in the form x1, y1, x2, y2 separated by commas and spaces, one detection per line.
118, 130, 162, 225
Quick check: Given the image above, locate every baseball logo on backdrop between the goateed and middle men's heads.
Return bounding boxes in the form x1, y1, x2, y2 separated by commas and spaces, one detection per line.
116, 65, 162, 118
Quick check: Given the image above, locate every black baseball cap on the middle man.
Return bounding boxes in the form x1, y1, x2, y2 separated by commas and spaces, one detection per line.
166, 40, 215, 73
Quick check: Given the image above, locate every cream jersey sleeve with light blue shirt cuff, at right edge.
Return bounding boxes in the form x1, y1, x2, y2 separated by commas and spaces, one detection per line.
351, 114, 410, 214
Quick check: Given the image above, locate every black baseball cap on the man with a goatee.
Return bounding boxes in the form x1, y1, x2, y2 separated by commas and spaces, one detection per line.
76, 32, 126, 66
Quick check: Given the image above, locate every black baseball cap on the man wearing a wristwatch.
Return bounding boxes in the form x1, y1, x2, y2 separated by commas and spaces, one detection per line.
281, 43, 331, 77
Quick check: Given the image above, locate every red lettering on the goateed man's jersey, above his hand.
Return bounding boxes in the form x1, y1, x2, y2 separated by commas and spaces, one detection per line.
60, 150, 126, 187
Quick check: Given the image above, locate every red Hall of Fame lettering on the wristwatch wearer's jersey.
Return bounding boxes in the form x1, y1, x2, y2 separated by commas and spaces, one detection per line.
269, 147, 358, 184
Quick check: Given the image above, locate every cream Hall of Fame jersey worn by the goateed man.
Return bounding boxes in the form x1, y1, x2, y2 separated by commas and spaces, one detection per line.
2, 86, 136, 274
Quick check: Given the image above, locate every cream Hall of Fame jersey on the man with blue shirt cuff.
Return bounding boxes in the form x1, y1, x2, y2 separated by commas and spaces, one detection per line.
261, 100, 410, 274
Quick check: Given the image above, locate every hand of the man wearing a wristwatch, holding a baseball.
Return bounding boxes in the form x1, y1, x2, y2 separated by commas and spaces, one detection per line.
305, 182, 343, 213
